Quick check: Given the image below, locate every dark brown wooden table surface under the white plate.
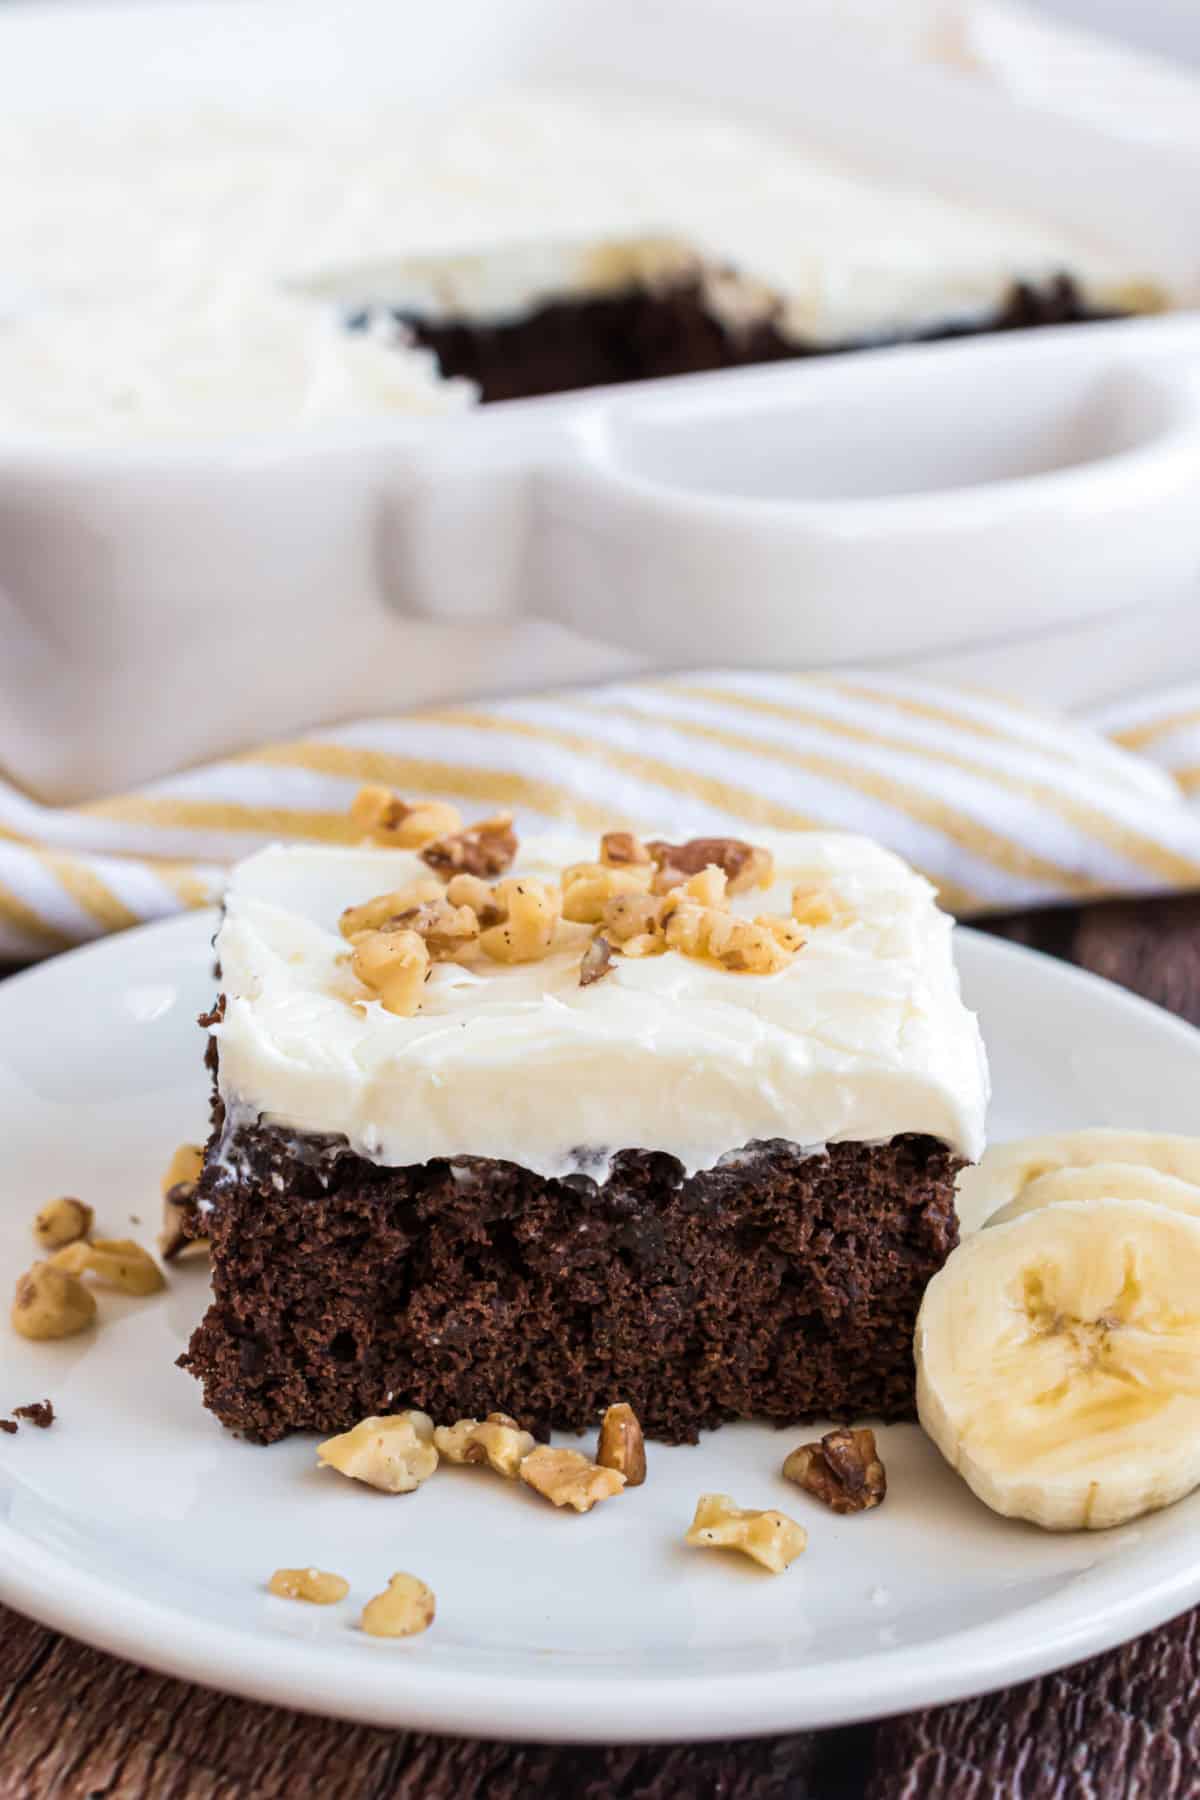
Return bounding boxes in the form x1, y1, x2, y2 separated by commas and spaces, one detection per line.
0, 896, 1200, 1800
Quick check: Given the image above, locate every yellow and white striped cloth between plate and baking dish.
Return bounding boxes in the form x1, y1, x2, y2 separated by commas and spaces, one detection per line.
0, 673, 1200, 959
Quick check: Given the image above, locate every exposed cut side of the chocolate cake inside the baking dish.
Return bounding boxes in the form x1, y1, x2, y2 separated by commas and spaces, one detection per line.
363, 236, 1166, 403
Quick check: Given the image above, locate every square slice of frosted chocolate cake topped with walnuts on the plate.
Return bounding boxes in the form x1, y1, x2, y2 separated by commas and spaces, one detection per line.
182, 824, 988, 1442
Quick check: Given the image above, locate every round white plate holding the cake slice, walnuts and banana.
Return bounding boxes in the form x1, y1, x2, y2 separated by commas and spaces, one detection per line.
0, 916, 1200, 1742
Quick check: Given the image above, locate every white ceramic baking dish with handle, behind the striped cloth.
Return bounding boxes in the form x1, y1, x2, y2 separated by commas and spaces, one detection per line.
0, 0, 1200, 801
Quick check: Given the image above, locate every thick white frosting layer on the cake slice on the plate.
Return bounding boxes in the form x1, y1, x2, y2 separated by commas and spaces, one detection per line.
216, 832, 988, 1179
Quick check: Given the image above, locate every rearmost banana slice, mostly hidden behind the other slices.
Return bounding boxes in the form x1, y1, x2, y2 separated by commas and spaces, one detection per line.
955, 1127, 1200, 1237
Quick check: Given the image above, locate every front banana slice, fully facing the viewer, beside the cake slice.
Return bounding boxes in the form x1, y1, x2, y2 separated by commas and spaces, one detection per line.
914, 1201, 1200, 1532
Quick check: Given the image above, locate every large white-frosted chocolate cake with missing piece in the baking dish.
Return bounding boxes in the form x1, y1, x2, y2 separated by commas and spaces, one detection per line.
0, 92, 1169, 437
